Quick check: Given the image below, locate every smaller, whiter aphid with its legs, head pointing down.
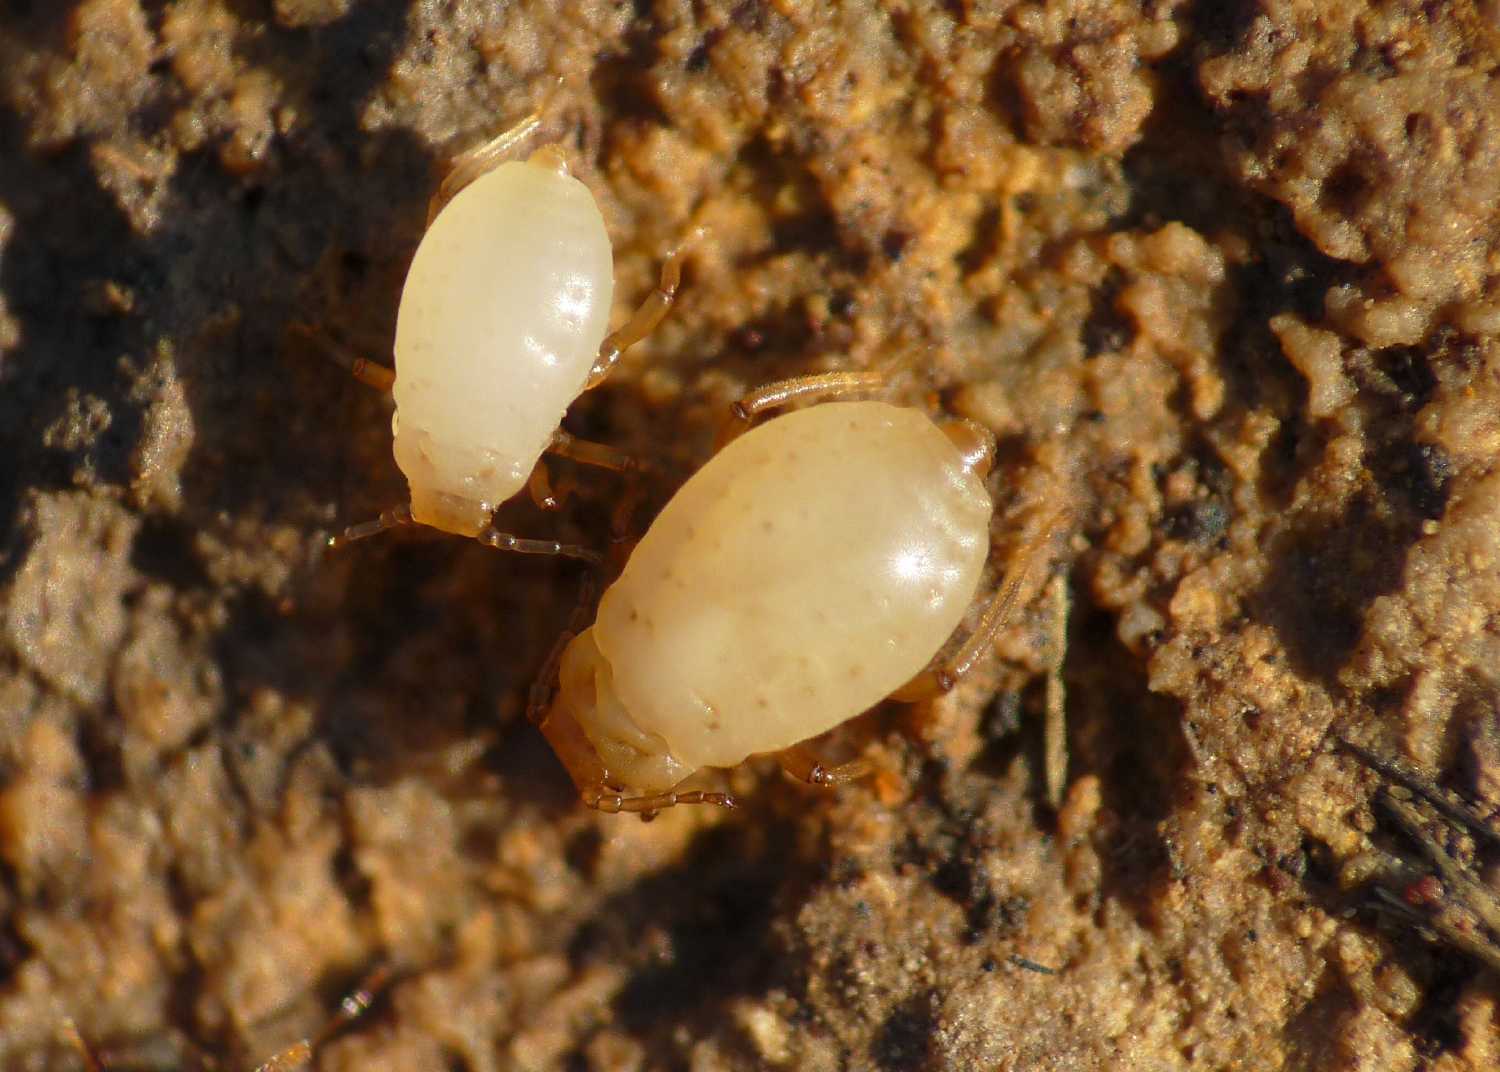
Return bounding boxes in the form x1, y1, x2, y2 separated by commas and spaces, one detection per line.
330, 117, 680, 559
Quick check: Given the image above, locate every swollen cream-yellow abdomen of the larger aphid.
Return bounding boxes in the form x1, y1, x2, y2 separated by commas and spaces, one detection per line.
594, 402, 992, 766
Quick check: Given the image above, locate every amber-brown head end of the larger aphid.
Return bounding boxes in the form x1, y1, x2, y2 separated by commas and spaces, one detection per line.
542, 628, 693, 793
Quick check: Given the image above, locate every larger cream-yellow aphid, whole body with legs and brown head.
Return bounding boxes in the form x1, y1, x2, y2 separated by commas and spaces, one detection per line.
533, 373, 1061, 813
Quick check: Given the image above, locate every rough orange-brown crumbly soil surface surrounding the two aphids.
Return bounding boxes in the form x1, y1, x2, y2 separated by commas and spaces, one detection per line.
0, 0, 1500, 1072
